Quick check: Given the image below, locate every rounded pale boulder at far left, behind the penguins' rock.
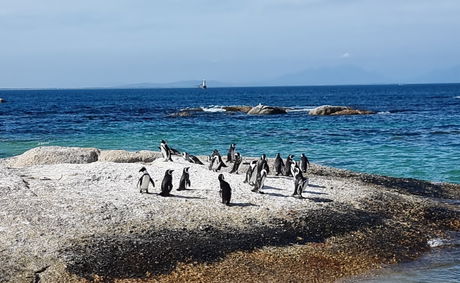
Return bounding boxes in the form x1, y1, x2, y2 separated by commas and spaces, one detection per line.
8, 146, 100, 167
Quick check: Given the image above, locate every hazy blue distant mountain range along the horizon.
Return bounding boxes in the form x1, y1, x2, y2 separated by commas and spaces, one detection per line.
116, 65, 460, 88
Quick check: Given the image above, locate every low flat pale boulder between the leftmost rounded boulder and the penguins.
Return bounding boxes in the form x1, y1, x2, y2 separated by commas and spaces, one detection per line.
98, 150, 161, 163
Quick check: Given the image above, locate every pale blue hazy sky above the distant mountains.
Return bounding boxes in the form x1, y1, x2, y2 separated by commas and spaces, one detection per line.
0, 0, 460, 88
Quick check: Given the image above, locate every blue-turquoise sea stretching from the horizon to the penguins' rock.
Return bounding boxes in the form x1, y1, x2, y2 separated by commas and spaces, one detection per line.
0, 84, 460, 183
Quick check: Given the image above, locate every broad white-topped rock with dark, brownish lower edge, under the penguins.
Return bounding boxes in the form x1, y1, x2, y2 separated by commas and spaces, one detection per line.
0, 149, 460, 282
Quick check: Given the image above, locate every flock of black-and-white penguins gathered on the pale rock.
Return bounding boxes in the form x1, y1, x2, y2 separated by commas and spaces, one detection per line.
136, 140, 310, 205
